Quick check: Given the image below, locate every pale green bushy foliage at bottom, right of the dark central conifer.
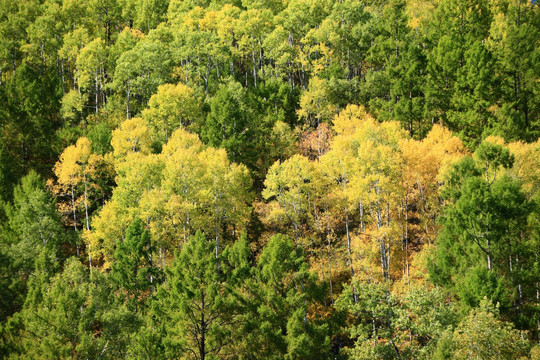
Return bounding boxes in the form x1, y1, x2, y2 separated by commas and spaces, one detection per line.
336, 281, 456, 359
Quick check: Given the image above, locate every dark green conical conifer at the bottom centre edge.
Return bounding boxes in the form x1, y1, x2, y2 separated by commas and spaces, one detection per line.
243, 235, 330, 359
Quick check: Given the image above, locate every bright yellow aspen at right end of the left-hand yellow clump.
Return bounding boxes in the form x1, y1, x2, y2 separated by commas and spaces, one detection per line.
163, 129, 252, 256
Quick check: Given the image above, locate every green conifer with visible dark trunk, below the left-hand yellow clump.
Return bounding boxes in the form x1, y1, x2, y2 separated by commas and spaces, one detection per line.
148, 232, 238, 360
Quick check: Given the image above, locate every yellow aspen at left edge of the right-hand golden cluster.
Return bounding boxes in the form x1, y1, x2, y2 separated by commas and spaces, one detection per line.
262, 154, 339, 303
